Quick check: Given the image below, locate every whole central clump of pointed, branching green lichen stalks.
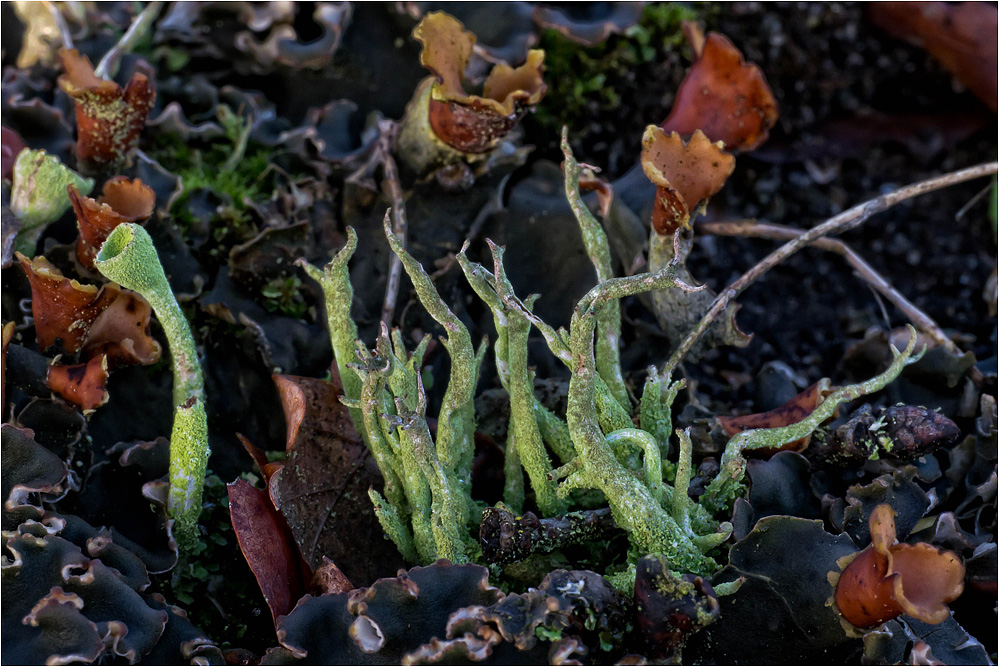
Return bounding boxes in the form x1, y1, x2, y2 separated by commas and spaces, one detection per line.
306, 133, 912, 589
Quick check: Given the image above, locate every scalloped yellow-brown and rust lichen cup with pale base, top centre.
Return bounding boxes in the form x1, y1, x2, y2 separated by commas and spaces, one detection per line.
398, 12, 546, 175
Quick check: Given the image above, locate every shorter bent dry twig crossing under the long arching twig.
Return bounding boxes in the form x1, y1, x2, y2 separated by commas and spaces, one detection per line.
696, 221, 958, 352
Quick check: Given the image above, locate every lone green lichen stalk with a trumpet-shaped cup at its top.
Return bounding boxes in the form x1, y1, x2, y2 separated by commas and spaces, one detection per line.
95, 223, 209, 551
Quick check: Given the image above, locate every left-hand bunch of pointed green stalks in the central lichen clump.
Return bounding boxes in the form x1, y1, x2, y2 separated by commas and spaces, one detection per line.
303, 215, 486, 563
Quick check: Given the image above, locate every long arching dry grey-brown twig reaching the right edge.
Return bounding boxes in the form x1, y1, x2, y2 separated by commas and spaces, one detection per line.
661, 162, 999, 378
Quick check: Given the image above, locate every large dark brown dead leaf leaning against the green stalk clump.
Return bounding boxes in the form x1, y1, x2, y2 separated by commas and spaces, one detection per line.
269, 375, 403, 586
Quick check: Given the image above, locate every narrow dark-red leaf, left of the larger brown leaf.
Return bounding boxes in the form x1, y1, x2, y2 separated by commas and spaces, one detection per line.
228, 479, 311, 624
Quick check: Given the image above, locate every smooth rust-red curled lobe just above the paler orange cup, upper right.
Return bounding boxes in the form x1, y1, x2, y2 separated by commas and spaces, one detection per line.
662, 22, 777, 152
